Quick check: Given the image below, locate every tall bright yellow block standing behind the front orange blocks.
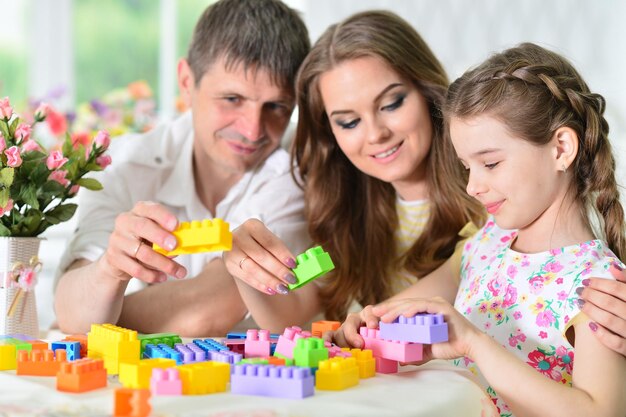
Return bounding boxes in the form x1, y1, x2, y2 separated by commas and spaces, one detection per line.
87, 324, 140, 374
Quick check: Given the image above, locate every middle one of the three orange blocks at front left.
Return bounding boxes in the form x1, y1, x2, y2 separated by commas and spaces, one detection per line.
57, 358, 107, 393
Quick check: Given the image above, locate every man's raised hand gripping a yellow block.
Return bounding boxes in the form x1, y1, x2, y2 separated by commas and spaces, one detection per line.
97, 201, 187, 283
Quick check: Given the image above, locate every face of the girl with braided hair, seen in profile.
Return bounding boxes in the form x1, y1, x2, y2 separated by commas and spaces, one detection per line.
450, 115, 567, 233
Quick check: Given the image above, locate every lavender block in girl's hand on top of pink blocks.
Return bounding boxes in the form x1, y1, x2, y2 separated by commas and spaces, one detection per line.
378, 314, 448, 344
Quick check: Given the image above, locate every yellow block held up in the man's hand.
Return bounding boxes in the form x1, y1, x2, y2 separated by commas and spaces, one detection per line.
152, 219, 233, 256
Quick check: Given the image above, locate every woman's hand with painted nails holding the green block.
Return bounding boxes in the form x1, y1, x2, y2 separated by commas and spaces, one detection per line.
222, 219, 297, 295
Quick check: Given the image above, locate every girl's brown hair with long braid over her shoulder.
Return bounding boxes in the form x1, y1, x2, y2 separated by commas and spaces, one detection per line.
445, 43, 626, 261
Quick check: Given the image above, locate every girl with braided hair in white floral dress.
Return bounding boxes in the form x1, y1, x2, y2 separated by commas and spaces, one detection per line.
346, 44, 626, 416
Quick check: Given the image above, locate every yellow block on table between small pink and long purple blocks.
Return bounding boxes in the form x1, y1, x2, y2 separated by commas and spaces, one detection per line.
177, 361, 230, 395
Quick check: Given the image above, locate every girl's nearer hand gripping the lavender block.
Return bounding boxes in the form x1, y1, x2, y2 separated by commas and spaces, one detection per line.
372, 297, 482, 363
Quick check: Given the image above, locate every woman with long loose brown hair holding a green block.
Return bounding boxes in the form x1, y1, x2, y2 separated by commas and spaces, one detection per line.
224, 11, 626, 353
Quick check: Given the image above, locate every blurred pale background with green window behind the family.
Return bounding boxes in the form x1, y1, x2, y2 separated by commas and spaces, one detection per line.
0, 0, 626, 327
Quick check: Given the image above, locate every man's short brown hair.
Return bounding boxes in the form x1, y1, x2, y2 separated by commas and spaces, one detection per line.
187, 0, 311, 90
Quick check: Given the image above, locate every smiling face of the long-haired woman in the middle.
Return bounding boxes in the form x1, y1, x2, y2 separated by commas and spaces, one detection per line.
320, 57, 432, 200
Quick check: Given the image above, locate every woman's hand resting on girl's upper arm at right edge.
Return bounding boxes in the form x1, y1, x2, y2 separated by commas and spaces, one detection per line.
579, 264, 626, 356
